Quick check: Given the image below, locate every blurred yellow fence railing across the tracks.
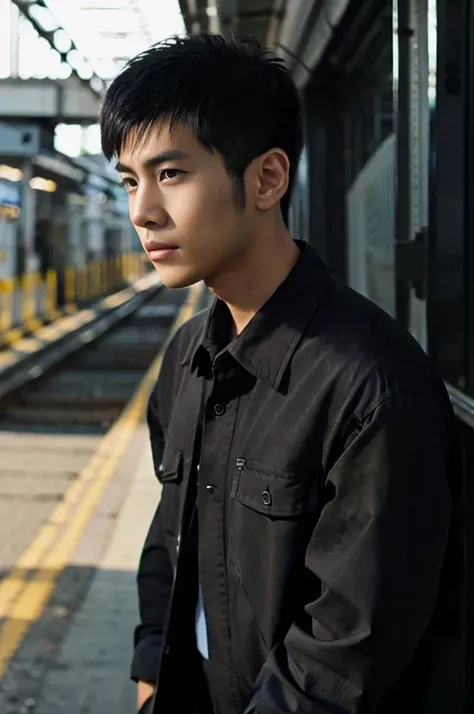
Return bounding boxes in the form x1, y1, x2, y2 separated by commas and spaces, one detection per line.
0, 253, 150, 346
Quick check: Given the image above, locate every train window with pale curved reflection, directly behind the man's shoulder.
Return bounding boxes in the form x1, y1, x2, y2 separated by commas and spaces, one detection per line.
344, 2, 396, 315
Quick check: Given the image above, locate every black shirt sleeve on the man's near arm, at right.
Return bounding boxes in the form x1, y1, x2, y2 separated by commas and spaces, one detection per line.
245, 395, 452, 714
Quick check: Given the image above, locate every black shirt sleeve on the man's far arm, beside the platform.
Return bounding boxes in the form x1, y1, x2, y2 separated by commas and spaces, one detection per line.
131, 392, 173, 682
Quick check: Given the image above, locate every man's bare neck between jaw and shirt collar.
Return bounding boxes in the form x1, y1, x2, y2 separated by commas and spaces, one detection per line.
208, 226, 300, 335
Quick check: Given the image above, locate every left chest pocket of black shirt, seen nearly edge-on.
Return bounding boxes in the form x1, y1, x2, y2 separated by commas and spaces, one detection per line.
158, 442, 184, 537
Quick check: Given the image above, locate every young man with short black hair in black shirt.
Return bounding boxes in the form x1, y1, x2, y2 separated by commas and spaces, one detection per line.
101, 36, 463, 714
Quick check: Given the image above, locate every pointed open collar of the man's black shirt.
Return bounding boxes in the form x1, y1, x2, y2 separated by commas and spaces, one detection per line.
182, 241, 331, 390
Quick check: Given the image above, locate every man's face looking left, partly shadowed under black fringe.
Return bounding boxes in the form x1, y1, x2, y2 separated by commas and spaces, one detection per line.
117, 125, 253, 288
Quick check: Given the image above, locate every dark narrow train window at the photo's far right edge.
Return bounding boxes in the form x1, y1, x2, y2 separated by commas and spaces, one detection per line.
427, 0, 473, 392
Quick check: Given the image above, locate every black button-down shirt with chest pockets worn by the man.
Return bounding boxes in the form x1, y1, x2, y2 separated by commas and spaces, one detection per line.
132, 244, 463, 714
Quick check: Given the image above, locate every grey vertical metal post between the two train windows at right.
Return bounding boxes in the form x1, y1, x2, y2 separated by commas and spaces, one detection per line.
390, 0, 432, 349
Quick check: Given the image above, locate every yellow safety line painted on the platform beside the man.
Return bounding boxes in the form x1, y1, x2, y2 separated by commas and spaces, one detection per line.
0, 285, 202, 678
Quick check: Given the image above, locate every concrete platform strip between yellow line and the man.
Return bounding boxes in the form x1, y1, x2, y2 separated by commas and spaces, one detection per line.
0, 424, 159, 714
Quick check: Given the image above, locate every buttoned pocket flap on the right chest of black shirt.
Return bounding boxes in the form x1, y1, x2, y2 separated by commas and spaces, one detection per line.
233, 462, 315, 518
